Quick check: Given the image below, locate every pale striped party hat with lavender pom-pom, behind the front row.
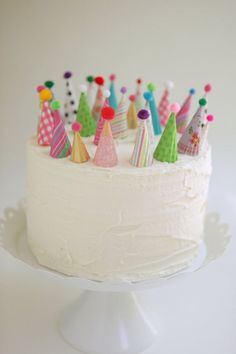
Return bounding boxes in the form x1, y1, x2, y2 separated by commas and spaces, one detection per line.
111, 87, 128, 138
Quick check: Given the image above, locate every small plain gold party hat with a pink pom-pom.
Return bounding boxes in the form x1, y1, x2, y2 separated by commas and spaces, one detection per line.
71, 122, 90, 163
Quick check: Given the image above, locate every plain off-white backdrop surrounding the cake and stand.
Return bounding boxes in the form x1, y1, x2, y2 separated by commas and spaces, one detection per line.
0, 0, 236, 354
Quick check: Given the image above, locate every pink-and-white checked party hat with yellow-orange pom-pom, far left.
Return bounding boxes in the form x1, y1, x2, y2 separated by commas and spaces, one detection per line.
38, 88, 54, 146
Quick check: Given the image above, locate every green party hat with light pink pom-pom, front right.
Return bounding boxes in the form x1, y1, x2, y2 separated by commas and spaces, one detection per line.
153, 103, 180, 162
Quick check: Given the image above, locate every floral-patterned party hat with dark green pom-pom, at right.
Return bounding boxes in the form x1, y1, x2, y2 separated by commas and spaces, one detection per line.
178, 98, 207, 156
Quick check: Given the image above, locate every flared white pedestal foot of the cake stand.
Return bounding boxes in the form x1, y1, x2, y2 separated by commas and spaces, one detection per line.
59, 291, 157, 354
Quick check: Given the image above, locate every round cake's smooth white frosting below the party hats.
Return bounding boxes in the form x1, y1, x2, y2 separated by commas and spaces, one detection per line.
27, 131, 211, 281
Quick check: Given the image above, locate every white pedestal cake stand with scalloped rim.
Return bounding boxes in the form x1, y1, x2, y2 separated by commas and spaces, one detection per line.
0, 204, 230, 354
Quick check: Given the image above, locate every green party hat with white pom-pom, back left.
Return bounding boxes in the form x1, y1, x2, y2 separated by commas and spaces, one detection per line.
76, 85, 96, 137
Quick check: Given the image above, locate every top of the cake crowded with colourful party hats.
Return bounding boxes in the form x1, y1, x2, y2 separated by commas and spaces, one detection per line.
37, 71, 214, 171
